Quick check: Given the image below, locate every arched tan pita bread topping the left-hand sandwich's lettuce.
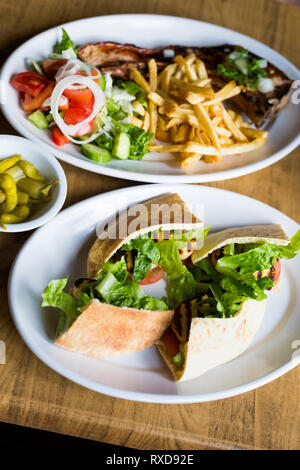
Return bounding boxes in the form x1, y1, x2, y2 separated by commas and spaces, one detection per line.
87, 193, 203, 278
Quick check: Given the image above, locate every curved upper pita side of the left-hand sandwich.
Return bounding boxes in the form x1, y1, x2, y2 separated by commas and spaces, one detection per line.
87, 194, 203, 278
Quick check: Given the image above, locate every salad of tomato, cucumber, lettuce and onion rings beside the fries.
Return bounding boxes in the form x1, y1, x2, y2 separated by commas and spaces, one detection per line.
11, 29, 153, 163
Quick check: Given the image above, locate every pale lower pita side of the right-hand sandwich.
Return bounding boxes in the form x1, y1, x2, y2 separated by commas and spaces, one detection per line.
156, 299, 266, 382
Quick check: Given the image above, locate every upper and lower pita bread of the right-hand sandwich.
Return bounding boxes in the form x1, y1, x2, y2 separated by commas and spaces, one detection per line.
156, 225, 289, 381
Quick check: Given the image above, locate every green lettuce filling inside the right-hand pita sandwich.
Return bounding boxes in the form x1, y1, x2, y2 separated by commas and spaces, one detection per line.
190, 231, 300, 317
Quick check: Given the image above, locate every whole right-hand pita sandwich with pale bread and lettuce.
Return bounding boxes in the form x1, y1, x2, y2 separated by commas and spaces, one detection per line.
156, 225, 300, 381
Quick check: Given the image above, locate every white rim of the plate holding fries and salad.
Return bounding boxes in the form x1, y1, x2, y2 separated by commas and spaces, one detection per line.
0, 14, 300, 184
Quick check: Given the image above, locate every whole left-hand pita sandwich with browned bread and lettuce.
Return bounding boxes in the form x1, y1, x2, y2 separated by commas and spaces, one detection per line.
42, 194, 204, 358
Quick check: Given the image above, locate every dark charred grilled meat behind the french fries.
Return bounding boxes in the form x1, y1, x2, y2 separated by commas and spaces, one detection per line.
78, 42, 292, 127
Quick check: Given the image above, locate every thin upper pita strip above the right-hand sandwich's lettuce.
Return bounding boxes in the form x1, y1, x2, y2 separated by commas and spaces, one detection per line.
192, 224, 289, 264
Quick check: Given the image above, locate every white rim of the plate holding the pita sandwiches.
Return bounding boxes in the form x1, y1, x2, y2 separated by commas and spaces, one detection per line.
7, 184, 300, 404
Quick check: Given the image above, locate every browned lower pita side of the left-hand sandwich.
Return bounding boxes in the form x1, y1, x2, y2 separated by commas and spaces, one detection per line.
55, 300, 174, 359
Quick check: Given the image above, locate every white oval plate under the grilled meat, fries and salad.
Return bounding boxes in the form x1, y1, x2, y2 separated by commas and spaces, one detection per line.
0, 15, 300, 183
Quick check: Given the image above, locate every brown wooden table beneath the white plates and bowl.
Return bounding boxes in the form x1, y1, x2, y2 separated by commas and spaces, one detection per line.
0, 0, 300, 449
